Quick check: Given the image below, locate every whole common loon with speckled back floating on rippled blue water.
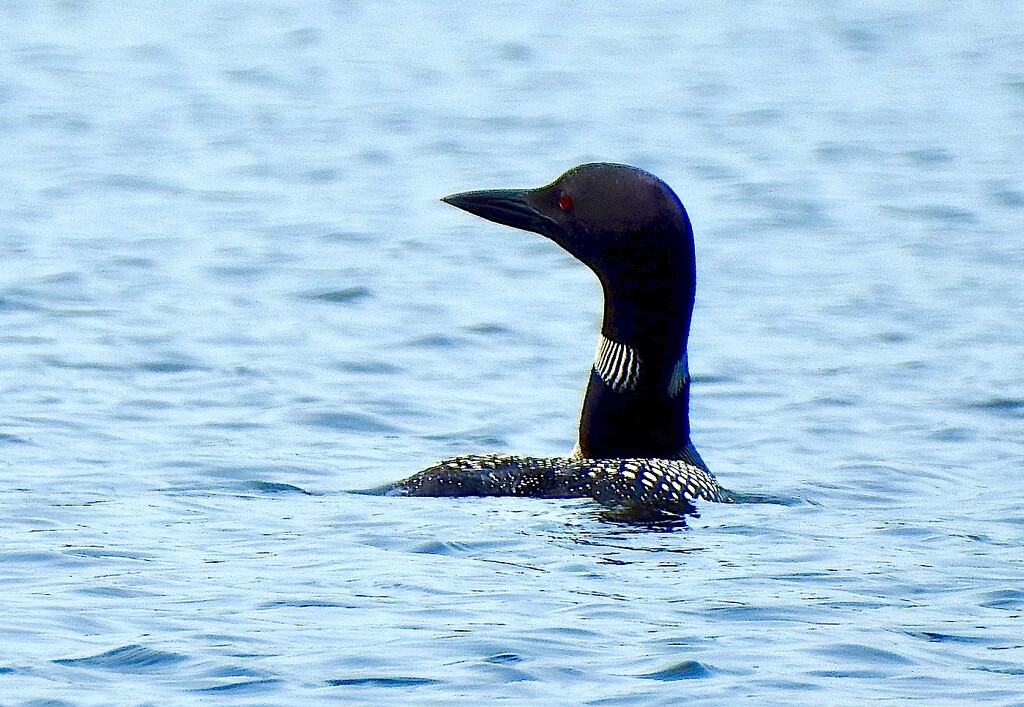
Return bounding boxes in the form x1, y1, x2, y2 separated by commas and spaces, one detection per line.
381, 163, 733, 513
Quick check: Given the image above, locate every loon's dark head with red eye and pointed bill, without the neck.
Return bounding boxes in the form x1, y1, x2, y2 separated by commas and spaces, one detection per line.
443, 162, 693, 277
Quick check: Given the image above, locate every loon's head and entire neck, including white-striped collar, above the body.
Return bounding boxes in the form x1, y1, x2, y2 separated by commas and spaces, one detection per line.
443, 163, 696, 458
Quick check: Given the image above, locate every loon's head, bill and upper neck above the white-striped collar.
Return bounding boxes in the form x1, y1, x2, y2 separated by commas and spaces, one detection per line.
443, 162, 695, 357
